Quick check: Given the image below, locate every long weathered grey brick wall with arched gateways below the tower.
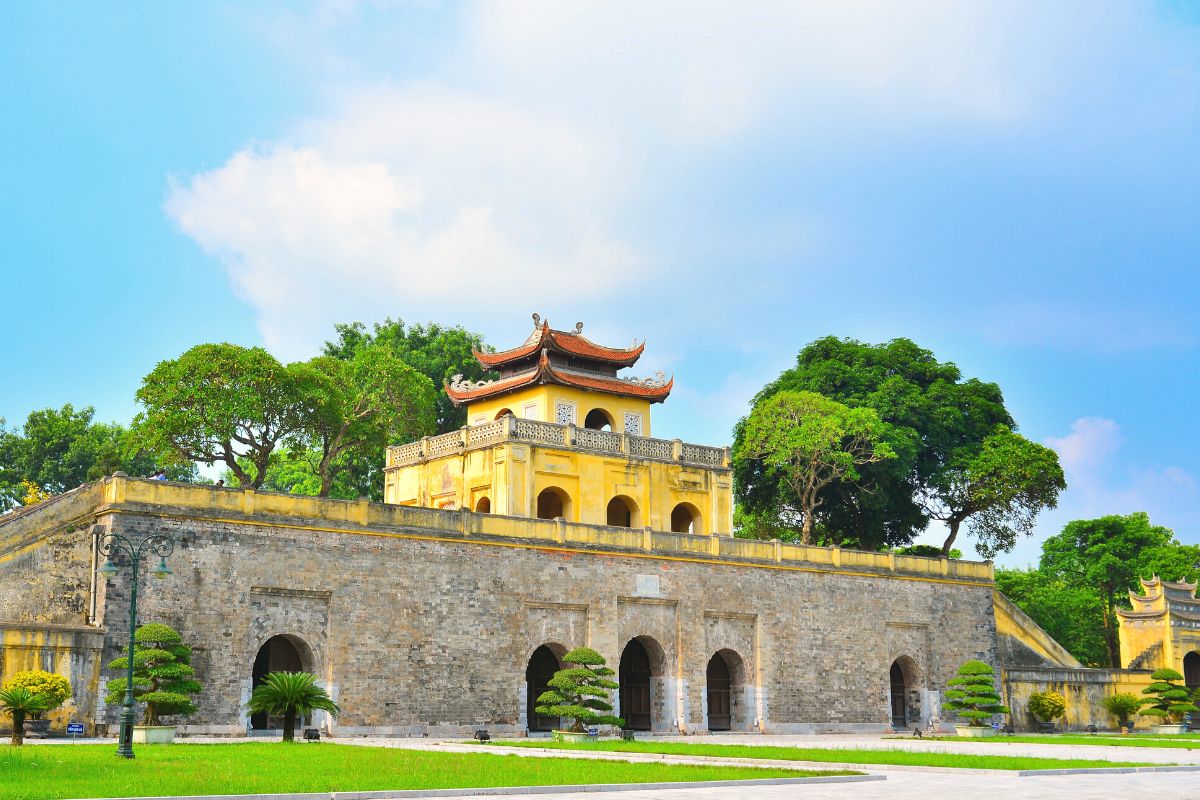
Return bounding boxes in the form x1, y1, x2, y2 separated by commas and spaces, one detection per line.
0, 481, 996, 735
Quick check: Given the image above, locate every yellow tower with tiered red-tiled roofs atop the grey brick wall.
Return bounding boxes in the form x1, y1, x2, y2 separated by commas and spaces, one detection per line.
384, 314, 733, 535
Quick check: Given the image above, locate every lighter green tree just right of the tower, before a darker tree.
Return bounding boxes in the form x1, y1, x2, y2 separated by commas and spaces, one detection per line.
734, 391, 895, 545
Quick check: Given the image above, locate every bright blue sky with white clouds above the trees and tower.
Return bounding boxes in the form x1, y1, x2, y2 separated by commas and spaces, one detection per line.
0, 0, 1200, 564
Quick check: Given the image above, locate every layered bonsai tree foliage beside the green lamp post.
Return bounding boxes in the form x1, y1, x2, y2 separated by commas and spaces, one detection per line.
104, 622, 200, 724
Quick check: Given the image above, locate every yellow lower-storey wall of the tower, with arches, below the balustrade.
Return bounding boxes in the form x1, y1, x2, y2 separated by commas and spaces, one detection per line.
388, 443, 733, 535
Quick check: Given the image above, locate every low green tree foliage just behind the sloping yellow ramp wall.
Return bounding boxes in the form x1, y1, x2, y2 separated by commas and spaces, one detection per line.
996, 569, 1109, 667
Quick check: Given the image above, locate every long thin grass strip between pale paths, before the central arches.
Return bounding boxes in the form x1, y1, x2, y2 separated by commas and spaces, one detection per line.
496, 740, 1156, 770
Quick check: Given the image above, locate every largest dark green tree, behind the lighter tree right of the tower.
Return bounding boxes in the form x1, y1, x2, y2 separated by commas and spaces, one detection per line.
733, 336, 1015, 549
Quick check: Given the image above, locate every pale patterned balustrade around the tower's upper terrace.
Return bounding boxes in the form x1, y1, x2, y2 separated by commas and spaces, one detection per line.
388, 416, 730, 469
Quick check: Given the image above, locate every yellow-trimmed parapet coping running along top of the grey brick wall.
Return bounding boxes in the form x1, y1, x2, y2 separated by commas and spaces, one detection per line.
0, 476, 992, 583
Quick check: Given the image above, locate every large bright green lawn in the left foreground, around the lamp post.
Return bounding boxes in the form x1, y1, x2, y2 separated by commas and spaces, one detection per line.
0, 742, 852, 800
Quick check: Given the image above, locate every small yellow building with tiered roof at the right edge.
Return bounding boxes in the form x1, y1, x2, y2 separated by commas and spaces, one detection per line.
1116, 576, 1200, 687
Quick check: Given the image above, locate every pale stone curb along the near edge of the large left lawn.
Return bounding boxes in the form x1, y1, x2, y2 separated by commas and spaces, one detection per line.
75, 775, 887, 800
